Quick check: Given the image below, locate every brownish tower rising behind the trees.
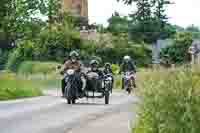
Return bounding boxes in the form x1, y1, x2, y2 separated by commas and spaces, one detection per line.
62, 0, 88, 19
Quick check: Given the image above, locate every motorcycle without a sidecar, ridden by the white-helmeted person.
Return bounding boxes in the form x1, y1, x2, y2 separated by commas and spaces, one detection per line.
123, 72, 136, 94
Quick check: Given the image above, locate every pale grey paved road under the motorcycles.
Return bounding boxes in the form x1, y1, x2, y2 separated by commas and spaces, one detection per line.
0, 91, 138, 133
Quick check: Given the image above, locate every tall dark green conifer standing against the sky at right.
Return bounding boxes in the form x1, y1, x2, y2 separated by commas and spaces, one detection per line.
118, 0, 175, 43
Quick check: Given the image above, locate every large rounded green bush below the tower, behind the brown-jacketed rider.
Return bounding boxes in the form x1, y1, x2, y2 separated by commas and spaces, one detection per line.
6, 24, 82, 72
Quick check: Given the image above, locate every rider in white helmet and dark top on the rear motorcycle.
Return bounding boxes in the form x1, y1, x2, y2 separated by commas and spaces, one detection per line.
120, 55, 136, 89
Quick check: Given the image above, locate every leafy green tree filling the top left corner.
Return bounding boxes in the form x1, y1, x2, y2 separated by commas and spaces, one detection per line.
0, 0, 48, 40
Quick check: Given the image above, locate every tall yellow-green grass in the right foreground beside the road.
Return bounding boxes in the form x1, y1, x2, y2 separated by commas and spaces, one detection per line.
133, 68, 200, 133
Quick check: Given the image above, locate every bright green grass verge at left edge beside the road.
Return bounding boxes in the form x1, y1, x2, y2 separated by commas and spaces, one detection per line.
0, 73, 42, 100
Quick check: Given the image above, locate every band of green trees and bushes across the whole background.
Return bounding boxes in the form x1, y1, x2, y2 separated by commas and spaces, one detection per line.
0, 0, 199, 70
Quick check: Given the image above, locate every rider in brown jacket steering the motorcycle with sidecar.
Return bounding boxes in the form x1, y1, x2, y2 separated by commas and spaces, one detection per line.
61, 51, 81, 96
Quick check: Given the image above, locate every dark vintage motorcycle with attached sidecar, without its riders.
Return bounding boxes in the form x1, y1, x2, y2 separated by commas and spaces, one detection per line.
64, 69, 113, 104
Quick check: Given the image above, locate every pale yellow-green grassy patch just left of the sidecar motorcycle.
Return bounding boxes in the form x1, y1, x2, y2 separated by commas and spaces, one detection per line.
17, 61, 61, 89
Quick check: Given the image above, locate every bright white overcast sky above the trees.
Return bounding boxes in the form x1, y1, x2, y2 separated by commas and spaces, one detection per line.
89, 0, 200, 27
